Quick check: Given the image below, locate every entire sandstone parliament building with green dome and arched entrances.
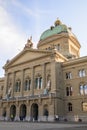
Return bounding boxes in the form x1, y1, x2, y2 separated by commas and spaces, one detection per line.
0, 19, 87, 121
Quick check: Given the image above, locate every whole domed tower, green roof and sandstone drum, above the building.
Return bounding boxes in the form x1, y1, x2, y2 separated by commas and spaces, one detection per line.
37, 19, 81, 59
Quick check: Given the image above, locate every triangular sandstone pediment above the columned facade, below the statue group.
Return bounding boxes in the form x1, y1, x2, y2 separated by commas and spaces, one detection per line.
4, 49, 49, 67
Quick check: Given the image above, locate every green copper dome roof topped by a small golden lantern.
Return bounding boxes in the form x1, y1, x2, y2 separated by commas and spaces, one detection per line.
40, 19, 76, 40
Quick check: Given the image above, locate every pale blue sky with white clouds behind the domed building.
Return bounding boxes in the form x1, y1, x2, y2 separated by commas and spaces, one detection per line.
0, 0, 87, 77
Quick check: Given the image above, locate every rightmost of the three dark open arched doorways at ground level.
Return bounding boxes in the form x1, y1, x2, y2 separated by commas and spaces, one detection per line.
31, 103, 38, 121
